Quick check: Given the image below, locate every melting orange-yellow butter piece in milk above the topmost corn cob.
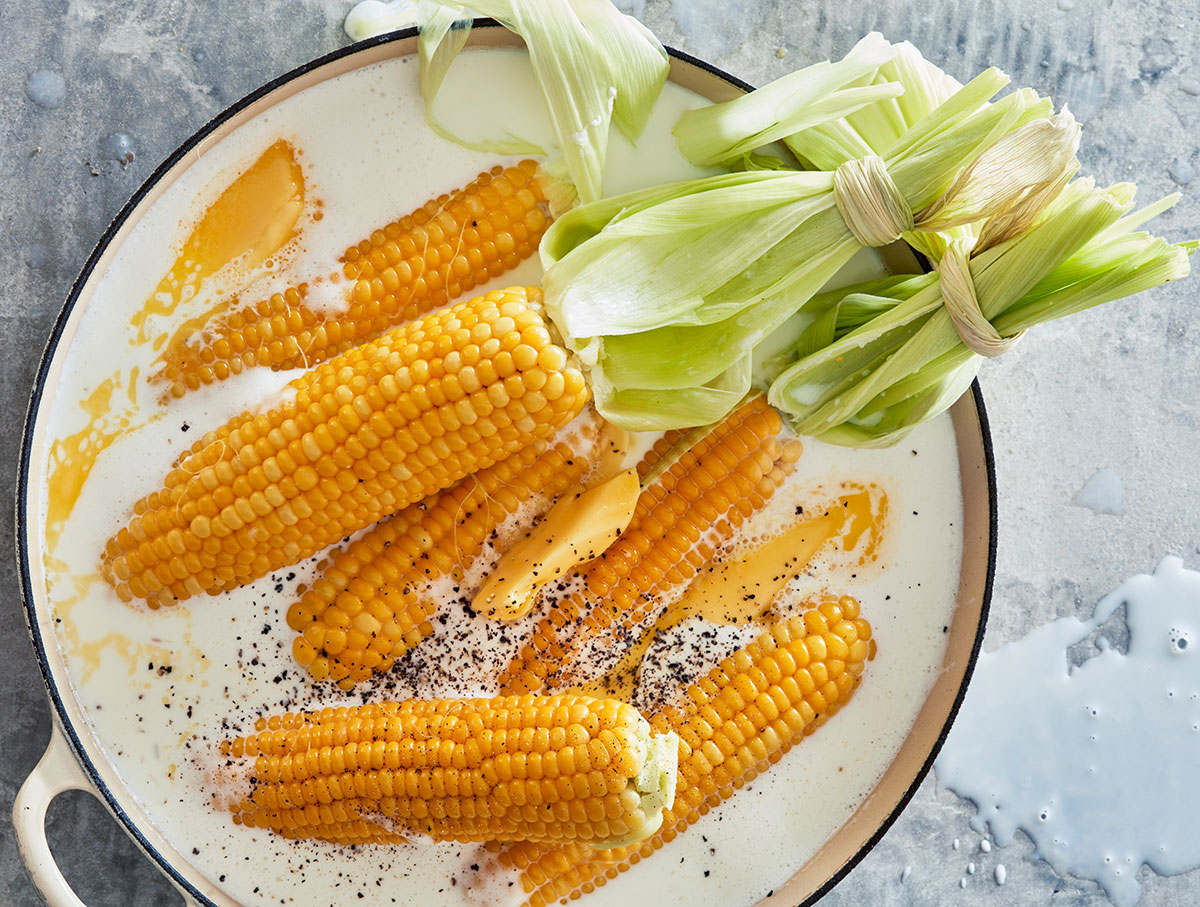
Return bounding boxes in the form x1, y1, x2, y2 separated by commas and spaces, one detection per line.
130, 139, 305, 349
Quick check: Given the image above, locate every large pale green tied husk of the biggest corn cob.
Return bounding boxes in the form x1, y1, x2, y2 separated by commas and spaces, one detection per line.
541, 58, 1078, 430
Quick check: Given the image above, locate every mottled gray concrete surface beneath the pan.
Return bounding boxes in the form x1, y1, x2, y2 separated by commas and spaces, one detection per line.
0, 0, 1200, 907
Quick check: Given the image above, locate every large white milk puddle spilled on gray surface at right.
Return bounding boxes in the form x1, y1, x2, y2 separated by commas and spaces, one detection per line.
935, 558, 1200, 907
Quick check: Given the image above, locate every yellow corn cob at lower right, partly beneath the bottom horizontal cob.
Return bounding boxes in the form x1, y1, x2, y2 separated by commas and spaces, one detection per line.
499, 596, 875, 907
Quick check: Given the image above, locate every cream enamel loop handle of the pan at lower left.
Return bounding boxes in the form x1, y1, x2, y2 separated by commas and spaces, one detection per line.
12, 725, 196, 907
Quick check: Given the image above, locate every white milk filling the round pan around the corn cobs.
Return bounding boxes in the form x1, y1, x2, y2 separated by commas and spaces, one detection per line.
34, 50, 962, 907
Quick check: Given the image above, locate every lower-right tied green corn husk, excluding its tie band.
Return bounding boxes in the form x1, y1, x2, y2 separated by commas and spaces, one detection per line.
768, 180, 1196, 448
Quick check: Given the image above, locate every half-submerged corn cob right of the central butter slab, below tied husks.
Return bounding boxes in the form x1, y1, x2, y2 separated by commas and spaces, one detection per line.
500, 397, 797, 692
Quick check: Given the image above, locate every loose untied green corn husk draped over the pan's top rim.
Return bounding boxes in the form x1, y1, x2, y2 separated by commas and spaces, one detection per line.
418, 0, 668, 202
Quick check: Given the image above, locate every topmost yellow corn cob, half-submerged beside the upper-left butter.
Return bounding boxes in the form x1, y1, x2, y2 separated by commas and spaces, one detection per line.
156, 161, 550, 397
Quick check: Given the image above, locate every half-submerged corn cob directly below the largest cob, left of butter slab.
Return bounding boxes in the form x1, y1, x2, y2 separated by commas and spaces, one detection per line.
287, 432, 595, 690
